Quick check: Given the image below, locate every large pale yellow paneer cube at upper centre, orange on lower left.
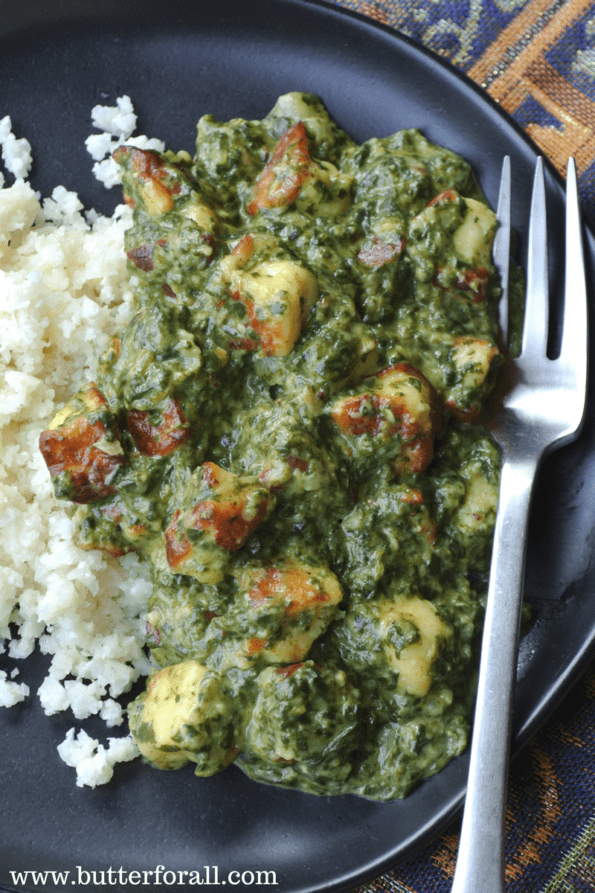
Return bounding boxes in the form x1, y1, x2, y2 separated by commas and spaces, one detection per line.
221, 234, 318, 357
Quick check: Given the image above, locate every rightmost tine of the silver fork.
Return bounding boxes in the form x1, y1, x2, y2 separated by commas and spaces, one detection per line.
560, 158, 587, 384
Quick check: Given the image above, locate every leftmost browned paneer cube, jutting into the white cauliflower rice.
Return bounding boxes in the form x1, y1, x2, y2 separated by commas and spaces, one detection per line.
39, 383, 125, 503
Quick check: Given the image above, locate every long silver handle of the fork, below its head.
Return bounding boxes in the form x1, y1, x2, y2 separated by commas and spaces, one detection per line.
452, 457, 539, 893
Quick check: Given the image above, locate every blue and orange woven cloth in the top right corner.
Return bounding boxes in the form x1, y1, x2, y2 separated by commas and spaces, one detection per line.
335, 0, 595, 220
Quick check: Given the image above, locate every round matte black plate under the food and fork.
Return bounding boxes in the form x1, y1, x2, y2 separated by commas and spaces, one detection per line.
0, 0, 595, 893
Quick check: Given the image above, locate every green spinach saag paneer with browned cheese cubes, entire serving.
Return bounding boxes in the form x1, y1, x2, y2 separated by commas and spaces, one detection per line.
40, 93, 501, 800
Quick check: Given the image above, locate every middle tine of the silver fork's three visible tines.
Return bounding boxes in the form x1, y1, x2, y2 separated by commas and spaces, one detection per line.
521, 157, 549, 359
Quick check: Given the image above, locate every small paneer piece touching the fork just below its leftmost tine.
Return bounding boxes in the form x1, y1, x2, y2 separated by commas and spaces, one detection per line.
445, 335, 500, 421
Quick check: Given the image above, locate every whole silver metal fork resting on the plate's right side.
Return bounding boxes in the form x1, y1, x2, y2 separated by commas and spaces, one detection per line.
452, 158, 587, 893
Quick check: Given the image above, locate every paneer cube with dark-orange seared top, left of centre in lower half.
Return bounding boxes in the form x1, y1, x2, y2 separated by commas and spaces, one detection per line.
165, 462, 275, 584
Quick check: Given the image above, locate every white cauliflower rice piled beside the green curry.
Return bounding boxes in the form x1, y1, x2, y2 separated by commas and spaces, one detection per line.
0, 97, 164, 787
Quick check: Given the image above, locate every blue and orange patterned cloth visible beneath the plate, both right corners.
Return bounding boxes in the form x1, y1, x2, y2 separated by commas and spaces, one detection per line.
334, 0, 595, 893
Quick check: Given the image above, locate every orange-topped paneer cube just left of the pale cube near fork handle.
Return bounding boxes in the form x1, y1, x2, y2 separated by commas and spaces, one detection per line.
237, 560, 343, 666
